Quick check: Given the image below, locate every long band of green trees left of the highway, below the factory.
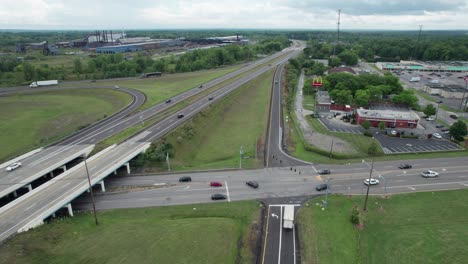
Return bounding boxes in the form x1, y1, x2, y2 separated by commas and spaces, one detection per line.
0, 36, 288, 86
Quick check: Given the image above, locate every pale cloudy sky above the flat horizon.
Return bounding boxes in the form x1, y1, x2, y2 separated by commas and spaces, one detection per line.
0, 0, 468, 30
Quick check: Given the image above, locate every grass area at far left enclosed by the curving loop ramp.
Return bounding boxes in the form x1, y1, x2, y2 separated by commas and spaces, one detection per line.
0, 89, 131, 160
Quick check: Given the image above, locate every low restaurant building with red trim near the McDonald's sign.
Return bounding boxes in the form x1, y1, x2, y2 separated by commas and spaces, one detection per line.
356, 109, 419, 128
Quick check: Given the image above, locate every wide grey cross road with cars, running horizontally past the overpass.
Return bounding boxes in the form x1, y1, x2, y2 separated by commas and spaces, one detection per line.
75, 157, 468, 210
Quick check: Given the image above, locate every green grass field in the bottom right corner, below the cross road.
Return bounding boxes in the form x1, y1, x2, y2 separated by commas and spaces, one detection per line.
297, 190, 468, 264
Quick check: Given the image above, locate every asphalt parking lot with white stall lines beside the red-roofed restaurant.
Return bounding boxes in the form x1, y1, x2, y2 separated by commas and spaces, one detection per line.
374, 134, 462, 154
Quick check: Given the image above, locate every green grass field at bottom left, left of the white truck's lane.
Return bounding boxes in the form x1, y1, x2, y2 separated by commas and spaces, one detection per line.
0, 201, 261, 264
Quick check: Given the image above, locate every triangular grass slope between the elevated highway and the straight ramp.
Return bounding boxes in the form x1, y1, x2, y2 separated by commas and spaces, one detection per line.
144, 70, 274, 170
